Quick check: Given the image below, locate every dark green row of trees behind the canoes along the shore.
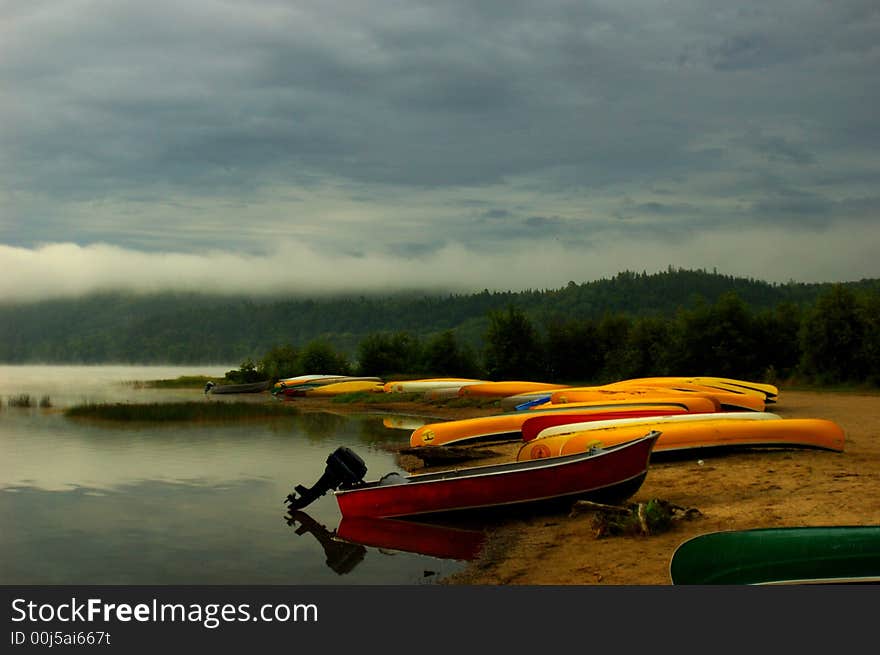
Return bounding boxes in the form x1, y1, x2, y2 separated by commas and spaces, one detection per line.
234, 284, 880, 386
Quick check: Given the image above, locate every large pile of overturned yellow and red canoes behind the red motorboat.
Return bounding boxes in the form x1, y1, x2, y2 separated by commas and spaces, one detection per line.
410, 376, 845, 461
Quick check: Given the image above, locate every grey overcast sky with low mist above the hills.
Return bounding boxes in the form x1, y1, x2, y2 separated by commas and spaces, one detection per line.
0, 0, 880, 299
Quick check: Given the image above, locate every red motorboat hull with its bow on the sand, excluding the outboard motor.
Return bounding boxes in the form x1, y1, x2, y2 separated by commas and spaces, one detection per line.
334, 431, 660, 517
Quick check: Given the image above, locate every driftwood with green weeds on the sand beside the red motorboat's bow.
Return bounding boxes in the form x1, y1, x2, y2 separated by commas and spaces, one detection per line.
569, 498, 703, 537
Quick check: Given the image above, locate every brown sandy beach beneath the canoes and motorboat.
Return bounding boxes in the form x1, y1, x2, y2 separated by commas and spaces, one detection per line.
288, 388, 880, 585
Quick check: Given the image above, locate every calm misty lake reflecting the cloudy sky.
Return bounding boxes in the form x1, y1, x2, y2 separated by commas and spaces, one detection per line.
0, 366, 475, 585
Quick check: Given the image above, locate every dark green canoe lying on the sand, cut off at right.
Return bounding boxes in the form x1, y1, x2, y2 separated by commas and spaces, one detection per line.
669, 525, 880, 585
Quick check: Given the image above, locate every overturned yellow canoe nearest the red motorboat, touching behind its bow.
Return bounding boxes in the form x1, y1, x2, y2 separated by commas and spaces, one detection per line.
517, 418, 845, 460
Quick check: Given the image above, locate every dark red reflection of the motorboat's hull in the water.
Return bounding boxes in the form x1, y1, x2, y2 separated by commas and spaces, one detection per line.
336, 517, 486, 560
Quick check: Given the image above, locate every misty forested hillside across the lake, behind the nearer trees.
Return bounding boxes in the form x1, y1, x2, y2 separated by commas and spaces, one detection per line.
0, 269, 880, 364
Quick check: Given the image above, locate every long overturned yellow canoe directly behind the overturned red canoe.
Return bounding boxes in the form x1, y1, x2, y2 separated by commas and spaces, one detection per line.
409, 403, 704, 448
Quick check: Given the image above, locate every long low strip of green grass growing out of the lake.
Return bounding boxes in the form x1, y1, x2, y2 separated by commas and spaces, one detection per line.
64, 401, 298, 423
